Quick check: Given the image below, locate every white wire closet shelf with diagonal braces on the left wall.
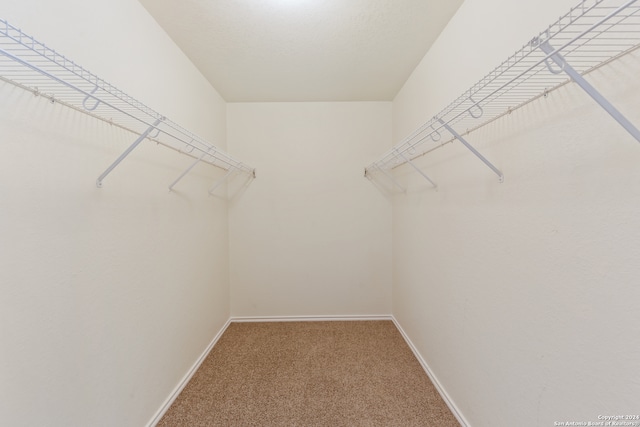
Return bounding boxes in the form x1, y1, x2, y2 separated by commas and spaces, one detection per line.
0, 19, 255, 192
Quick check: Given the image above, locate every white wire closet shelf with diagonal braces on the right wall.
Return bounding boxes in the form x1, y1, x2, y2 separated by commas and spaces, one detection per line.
365, 0, 640, 191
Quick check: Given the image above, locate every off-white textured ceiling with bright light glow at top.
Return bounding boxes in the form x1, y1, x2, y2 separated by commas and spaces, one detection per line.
140, 0, 463, 102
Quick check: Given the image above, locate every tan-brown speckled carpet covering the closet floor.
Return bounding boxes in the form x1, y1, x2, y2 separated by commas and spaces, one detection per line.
158, 321, 459, 427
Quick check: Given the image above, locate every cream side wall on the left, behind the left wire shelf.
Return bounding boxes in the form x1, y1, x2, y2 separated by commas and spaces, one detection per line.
0, 0, 229, 426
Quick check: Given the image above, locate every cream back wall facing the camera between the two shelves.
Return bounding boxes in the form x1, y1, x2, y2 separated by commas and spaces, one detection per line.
228, 102, 391, 316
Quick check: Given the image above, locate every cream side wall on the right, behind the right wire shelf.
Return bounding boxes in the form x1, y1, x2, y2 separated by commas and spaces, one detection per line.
393, 0, 640, 427
